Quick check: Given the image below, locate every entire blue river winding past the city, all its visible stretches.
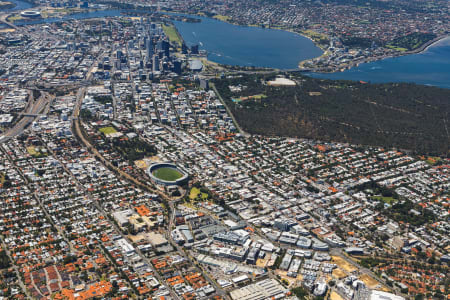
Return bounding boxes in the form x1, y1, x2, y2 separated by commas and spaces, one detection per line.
3, 0, 450, 88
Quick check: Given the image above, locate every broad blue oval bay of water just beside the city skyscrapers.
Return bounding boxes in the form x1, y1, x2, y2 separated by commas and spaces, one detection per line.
174, 16, 322, 69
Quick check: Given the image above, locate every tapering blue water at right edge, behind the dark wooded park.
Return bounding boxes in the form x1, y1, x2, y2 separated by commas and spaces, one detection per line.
308, 37, 450, 88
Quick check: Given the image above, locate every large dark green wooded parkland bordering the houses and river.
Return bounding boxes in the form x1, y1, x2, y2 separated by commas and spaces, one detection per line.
215, 74, 450, 155
